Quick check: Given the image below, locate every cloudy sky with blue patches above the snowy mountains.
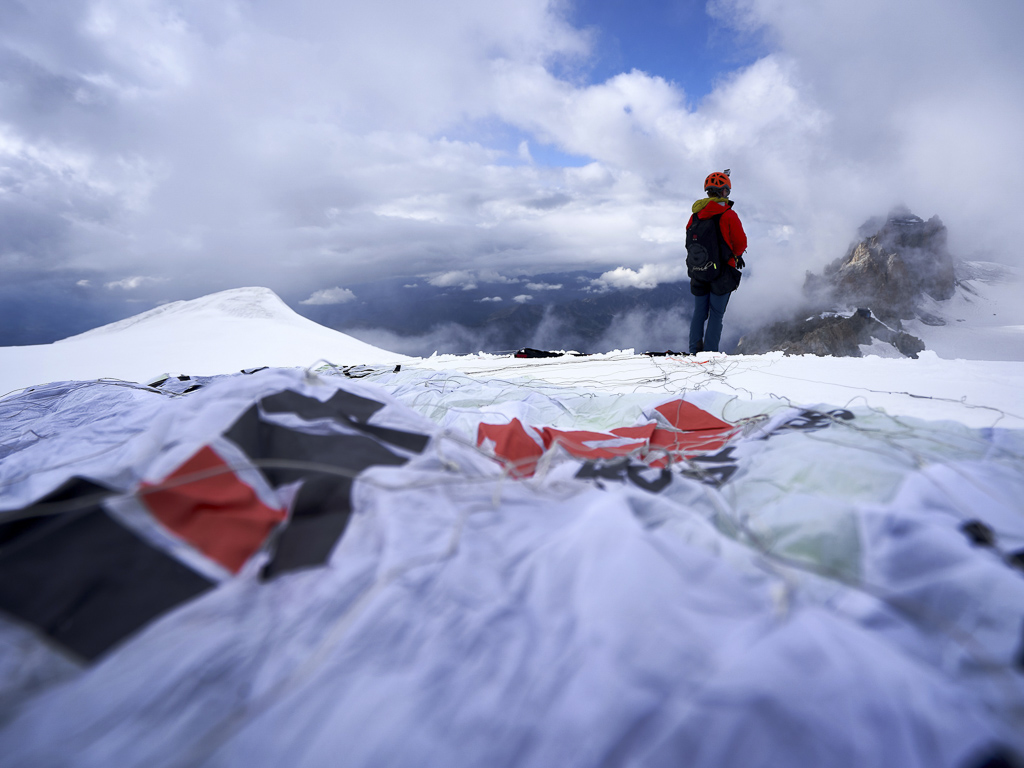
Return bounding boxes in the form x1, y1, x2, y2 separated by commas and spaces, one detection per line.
0, 0, 1024, 344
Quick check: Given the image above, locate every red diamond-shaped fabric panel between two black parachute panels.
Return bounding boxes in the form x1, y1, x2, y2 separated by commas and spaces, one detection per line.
140, 445, 287, 573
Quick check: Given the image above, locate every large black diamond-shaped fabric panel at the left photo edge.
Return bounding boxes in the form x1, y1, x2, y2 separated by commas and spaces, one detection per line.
0, 493, 214, 660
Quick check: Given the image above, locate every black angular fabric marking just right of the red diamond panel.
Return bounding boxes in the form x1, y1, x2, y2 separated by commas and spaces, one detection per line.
224, 406, 407, 578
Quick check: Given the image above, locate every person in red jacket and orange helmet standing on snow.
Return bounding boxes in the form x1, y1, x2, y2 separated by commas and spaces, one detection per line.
686, 170, 746, 354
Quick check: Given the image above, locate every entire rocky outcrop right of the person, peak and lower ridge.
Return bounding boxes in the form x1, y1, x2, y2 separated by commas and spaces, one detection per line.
736, 209, 956, 357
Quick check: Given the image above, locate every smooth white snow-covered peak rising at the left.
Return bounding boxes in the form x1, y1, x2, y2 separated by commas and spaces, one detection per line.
0, 288, 407, 395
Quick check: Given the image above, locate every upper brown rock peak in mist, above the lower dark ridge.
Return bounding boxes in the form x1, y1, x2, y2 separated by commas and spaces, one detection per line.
804, 209, 956, 324
